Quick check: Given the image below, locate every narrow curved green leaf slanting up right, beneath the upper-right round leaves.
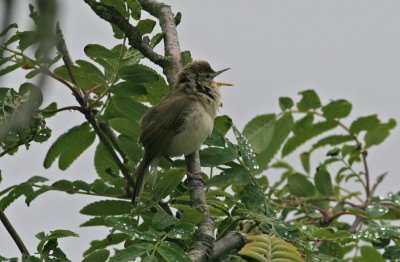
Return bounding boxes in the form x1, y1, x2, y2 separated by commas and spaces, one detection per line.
282, 121, 337, 157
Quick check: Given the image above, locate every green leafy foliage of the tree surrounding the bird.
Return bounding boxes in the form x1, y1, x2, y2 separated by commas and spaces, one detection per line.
0, 0, 400, 261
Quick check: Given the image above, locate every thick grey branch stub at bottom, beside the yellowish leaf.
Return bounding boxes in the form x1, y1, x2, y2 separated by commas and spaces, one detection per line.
211, 231, 246, 260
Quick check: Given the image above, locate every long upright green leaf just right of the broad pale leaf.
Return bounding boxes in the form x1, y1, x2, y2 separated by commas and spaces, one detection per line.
256, 113, 293, 170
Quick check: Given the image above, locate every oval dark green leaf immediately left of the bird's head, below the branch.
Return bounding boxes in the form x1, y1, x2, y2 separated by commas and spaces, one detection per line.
119, 64, 159, 83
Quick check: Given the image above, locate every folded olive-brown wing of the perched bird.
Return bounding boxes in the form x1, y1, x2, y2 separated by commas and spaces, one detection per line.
139, 91, 193, 157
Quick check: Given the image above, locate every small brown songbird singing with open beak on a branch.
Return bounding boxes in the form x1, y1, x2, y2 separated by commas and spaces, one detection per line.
132, 60, 232, 205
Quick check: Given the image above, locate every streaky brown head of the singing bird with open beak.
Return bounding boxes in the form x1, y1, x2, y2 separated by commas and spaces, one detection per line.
177, 60, 231, 87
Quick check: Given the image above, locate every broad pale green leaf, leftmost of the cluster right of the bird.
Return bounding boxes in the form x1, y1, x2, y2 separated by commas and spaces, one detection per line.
243, 114, 276, 154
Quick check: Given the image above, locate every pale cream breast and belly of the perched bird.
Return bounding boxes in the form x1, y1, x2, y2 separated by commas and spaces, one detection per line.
166, 104, 215, 156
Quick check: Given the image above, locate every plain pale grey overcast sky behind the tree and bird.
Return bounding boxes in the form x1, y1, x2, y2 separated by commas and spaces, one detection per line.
0, 0, 400, 261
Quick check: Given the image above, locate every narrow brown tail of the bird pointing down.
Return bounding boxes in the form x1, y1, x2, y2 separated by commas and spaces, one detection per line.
132, 157, 159, 205
